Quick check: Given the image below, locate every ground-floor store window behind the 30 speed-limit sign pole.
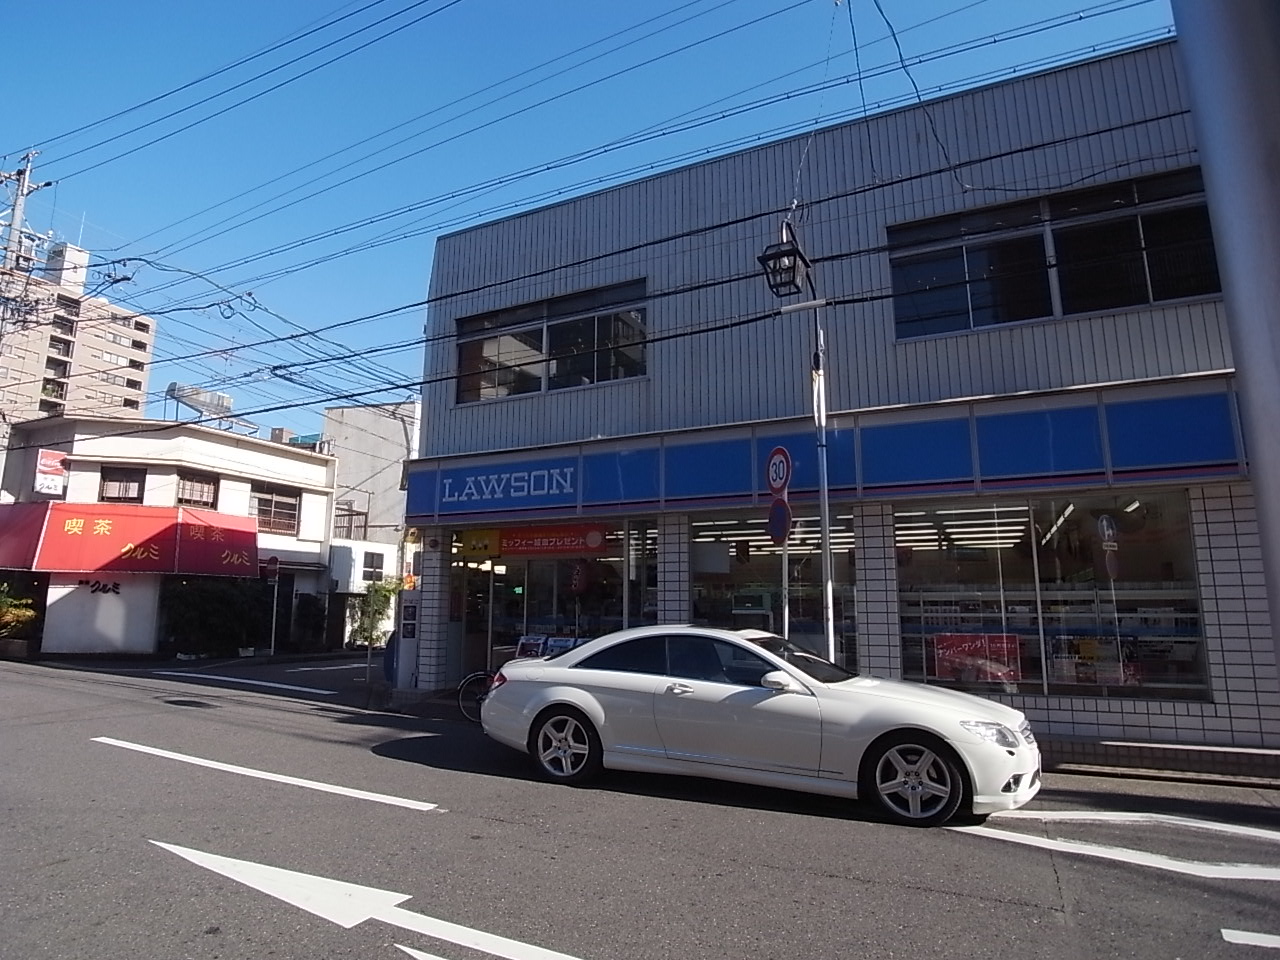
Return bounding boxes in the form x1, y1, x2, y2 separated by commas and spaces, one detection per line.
689, 507, 856, 669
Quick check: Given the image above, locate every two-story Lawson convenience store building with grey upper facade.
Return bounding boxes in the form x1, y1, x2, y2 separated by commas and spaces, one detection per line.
403, 42, 1280, 748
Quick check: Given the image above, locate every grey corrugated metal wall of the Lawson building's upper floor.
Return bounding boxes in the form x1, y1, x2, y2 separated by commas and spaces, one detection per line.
422, 42, 1231, 456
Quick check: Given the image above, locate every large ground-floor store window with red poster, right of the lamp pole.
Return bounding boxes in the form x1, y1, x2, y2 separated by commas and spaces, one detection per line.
895, 492, 1208, 699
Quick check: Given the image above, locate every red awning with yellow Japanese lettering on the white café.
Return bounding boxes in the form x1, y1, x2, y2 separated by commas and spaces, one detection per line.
0, 500, 259, 577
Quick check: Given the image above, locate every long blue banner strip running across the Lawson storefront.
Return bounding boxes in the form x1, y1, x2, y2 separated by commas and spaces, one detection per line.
406, 390, 1245, 522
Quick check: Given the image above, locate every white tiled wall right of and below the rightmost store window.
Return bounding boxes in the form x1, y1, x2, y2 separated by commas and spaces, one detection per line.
998, 484, 1280, 748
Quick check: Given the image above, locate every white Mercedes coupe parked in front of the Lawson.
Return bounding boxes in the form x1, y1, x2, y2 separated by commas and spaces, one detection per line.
480, 626, 1041, 827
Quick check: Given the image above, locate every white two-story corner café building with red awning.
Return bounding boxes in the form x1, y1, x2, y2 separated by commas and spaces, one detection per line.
0, 416, 343, 654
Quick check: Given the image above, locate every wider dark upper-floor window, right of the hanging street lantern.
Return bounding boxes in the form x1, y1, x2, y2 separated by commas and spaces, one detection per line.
887, 169, 1222, 339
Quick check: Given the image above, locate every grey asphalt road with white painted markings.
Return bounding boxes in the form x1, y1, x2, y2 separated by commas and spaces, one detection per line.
0, 662, 1280, 960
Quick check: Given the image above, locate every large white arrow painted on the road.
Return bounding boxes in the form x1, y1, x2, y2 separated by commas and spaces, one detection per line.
151, 840, 577, 960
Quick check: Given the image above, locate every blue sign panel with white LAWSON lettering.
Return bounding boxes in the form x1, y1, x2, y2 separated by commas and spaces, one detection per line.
408, 457, 579, 513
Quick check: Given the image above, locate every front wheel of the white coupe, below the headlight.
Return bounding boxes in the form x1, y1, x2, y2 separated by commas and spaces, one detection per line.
858, 731, 965, 827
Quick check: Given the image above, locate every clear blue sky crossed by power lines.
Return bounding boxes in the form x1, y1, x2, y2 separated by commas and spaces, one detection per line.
0, 0, 1172, 433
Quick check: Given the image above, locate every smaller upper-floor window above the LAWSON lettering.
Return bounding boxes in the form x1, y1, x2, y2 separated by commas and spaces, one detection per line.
457, 280, 648, 403
